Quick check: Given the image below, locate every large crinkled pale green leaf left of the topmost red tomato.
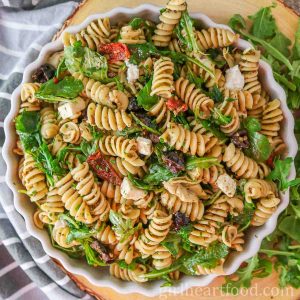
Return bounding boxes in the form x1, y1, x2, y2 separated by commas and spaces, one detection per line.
64, 41, 108, 81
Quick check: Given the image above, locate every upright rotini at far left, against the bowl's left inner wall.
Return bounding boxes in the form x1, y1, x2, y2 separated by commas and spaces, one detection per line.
20, 153, 48, 202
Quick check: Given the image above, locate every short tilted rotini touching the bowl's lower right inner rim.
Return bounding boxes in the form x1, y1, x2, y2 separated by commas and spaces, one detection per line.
251, 194, 280, 226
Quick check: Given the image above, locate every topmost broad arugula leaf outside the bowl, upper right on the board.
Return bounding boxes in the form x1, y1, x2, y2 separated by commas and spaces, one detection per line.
249, 6, 277, 39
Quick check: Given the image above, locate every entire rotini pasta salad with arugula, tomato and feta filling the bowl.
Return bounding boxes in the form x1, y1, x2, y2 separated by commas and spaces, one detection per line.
14, 0, 286, 284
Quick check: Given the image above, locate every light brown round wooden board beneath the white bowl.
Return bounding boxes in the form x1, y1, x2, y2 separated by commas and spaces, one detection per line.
54, 0, 300, 300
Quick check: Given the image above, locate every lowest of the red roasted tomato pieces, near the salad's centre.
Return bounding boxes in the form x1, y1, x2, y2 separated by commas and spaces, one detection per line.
87, 151, 122, 185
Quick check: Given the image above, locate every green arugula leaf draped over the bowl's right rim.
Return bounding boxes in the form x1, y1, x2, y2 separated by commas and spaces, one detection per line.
267, 157, 300, 191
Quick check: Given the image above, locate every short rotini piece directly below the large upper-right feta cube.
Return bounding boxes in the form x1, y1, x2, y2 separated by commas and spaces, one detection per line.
223, 89, 254, 116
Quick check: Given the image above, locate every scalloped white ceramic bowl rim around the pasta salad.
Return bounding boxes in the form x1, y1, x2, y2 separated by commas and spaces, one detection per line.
3, 4, 297, 296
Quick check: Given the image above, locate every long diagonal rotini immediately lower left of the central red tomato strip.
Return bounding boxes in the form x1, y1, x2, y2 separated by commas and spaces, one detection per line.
71, 162, 110, 221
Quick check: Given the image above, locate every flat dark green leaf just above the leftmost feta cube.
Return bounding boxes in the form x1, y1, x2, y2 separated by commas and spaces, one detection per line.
35, 76, 83, 102
